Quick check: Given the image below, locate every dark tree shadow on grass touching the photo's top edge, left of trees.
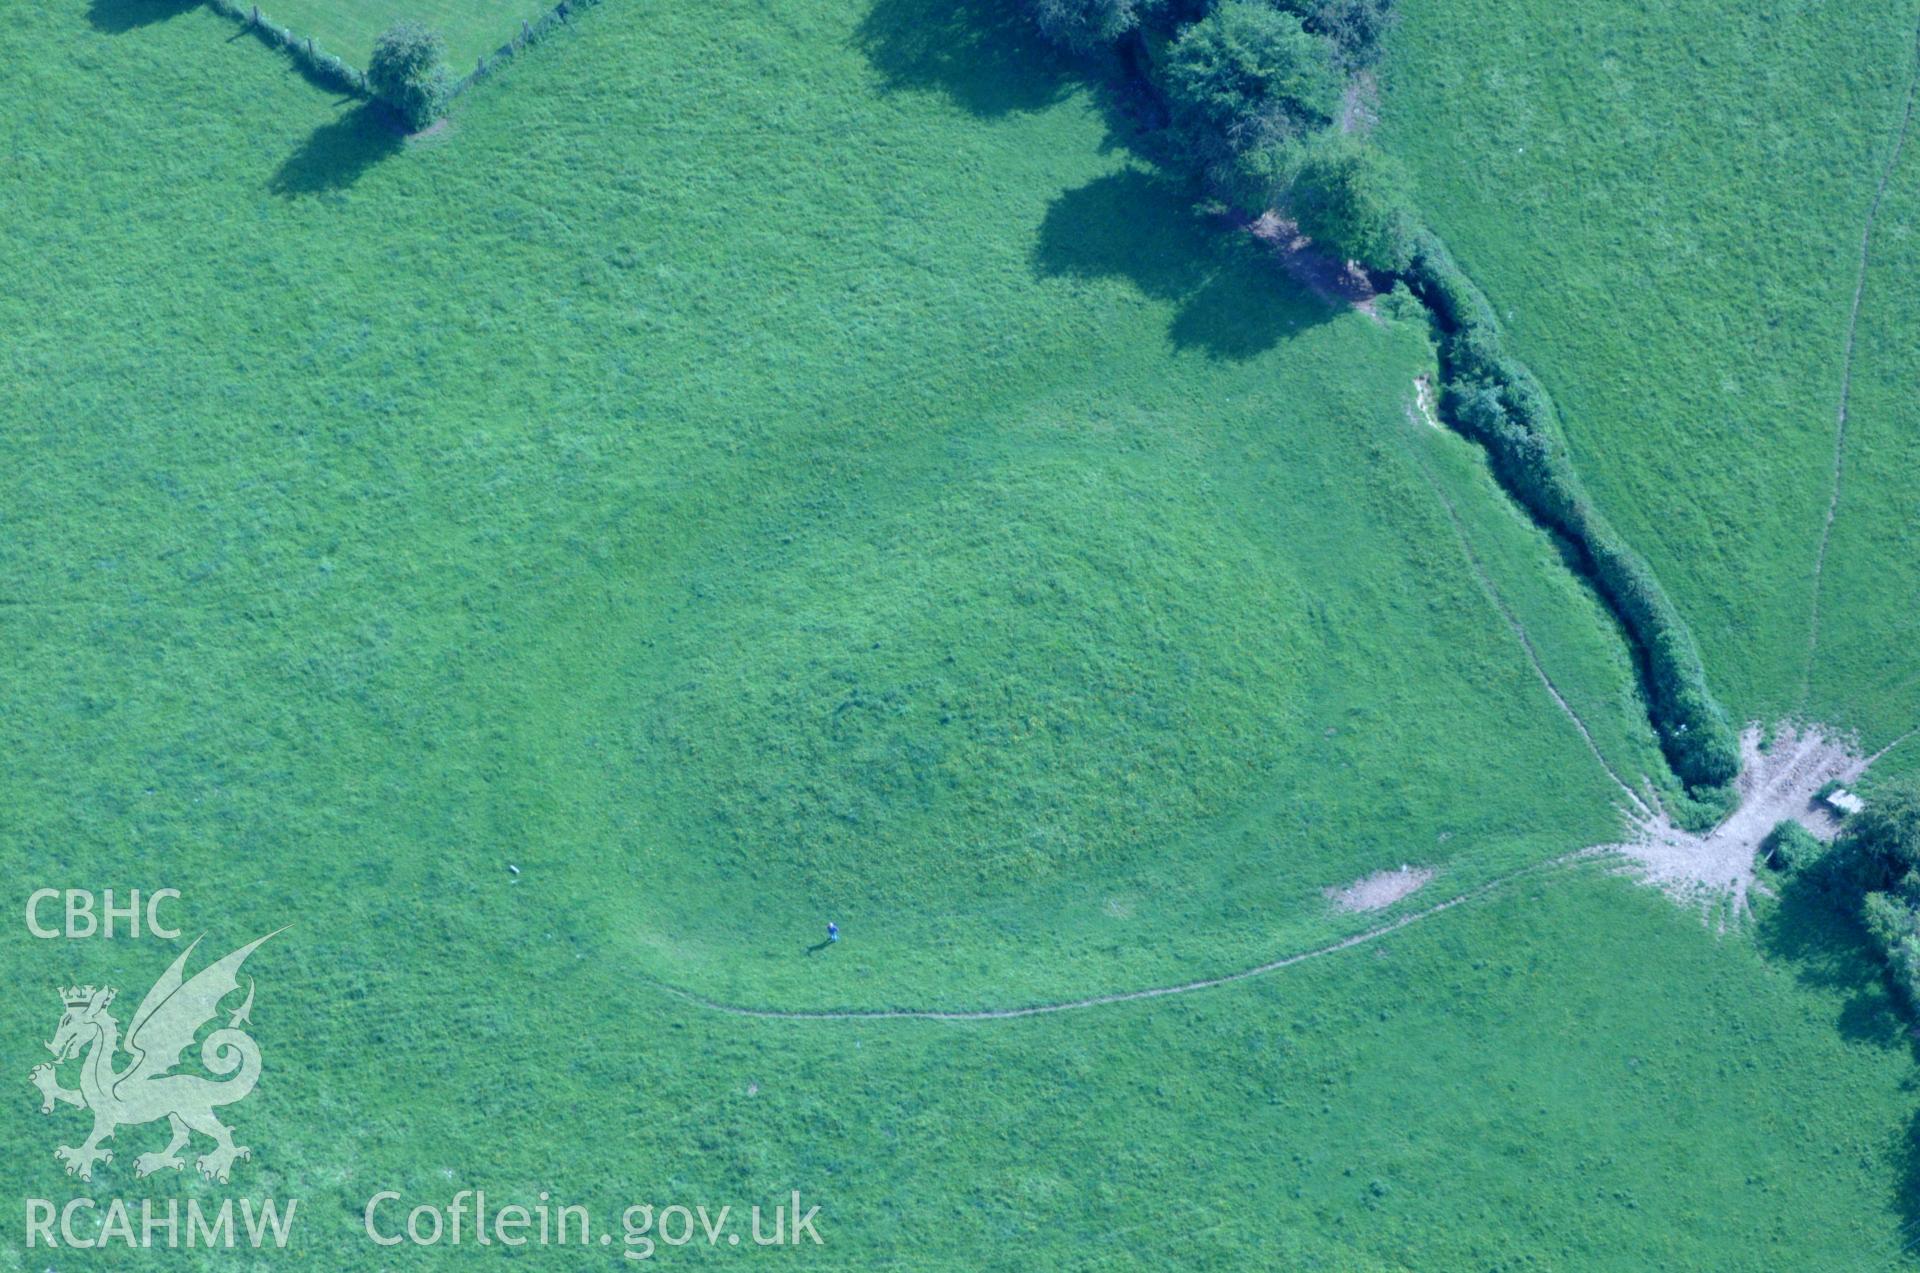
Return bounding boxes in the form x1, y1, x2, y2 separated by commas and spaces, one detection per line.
854, 0, 1071, 115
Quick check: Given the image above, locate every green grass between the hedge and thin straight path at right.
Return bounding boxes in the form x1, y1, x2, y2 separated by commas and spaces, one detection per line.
1382, 0, 1920, 737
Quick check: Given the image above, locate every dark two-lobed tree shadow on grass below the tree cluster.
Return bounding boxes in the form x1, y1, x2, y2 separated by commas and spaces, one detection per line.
1033, 167, 1338, 359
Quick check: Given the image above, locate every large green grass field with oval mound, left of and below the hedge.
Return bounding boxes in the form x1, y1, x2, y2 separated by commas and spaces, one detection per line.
11, 0, 1920, 1273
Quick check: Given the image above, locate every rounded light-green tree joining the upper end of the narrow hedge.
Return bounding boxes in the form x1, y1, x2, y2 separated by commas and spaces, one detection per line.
1286, 132, 1415, 273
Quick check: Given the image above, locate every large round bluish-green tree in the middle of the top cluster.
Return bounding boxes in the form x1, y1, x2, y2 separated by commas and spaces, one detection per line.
1165, 0, 1340, 177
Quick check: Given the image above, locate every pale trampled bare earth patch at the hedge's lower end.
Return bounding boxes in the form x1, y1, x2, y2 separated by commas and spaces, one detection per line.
1615, 726, 1866, 916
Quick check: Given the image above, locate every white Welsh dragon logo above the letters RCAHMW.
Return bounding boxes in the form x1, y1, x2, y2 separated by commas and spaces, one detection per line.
33, 929, 286, 1183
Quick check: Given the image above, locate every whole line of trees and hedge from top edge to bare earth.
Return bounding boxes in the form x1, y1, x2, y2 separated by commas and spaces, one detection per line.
1029, 0, 1740, 787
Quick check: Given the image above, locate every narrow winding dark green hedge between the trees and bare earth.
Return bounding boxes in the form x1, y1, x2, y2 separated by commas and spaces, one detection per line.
1405, 230, 1740, 785
